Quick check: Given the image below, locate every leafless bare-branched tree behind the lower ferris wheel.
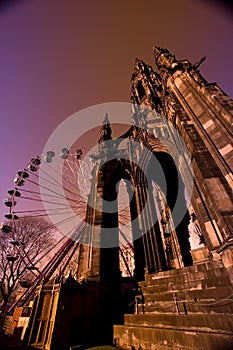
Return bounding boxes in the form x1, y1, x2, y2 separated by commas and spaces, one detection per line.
0, 217, 54, 305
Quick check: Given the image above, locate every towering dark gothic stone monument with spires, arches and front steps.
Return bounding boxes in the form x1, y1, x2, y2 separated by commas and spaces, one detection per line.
25, 47, 233, 350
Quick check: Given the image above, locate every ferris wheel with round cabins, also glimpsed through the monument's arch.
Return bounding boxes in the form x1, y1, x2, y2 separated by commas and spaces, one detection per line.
1, 147, 134, 304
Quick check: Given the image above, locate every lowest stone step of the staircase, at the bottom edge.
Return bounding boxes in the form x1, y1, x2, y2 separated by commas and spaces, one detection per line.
114, 325, 233, 350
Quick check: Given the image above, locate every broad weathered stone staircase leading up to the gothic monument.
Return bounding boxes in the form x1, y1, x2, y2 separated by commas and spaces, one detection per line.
114, 259, 233, 350
